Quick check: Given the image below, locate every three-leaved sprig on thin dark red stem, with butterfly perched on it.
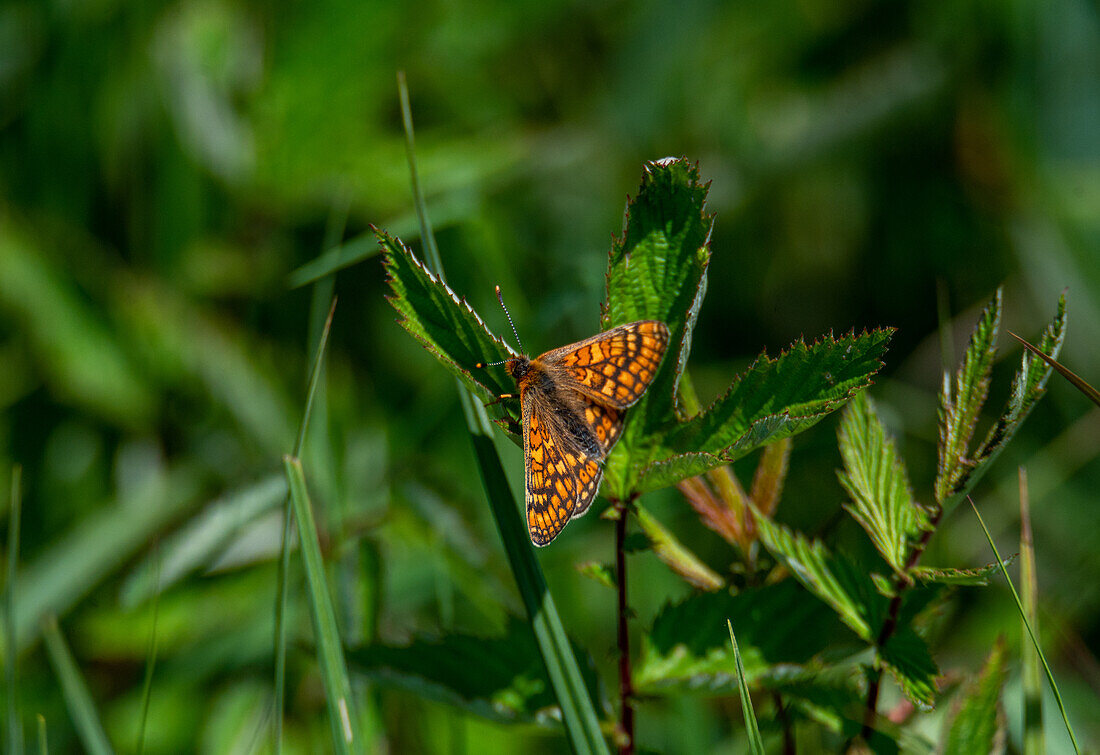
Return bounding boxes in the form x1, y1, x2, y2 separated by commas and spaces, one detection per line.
372, 160, 919, 749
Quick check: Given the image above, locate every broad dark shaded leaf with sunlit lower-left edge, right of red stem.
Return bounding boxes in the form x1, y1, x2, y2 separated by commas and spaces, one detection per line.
634, 580, 844, 694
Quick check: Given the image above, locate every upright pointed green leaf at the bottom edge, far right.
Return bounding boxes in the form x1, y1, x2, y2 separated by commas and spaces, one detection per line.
943, 637, 1008, 755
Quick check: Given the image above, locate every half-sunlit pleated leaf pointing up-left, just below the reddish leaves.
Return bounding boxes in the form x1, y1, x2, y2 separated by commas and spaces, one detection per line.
756, 515, 886, 642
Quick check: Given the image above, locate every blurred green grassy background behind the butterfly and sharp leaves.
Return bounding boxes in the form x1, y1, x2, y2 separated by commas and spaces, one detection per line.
0, 0, 1100, 753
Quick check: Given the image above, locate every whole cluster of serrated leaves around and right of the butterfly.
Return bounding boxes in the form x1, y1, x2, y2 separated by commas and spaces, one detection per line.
374, 160, 1065, 748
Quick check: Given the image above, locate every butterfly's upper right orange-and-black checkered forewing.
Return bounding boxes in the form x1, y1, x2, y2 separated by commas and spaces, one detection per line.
539, 320, 669, 409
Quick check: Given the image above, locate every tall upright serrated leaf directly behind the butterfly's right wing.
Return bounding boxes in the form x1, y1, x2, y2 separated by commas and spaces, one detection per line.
601, 158, 714, 500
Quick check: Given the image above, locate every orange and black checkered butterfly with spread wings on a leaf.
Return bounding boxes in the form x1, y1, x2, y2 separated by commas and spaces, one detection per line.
477, 287, 669, 546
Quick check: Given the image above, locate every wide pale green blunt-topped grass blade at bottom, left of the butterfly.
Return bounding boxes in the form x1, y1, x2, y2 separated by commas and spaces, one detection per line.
283, 456, 362, 753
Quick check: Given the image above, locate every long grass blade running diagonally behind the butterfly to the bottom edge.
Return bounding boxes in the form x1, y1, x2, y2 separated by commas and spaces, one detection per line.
397, 72, 607, 753
